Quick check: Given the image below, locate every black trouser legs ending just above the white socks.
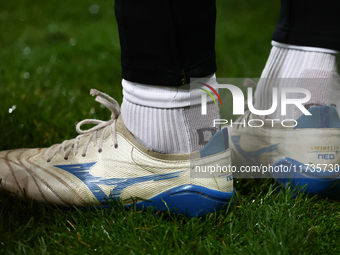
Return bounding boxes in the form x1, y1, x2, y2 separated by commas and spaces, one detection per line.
115, 0, 340, 86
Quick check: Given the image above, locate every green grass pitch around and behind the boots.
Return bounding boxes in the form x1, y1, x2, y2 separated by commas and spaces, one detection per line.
0, 0, 340, 254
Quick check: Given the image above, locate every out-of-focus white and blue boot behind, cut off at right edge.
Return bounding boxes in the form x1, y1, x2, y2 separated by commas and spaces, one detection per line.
229, 79, 340, 198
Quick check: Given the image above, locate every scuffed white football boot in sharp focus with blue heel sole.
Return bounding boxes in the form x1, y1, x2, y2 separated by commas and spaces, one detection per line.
0, 90, 234, 217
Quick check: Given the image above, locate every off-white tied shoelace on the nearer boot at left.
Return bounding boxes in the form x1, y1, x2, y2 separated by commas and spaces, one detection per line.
45, 89, 120, 162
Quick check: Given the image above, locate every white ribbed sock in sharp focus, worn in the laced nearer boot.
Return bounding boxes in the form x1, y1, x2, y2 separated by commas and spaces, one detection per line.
121, 75, 219, 154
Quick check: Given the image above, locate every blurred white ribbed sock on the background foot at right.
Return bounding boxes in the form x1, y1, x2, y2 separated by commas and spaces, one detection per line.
255, 42, 339, 120
